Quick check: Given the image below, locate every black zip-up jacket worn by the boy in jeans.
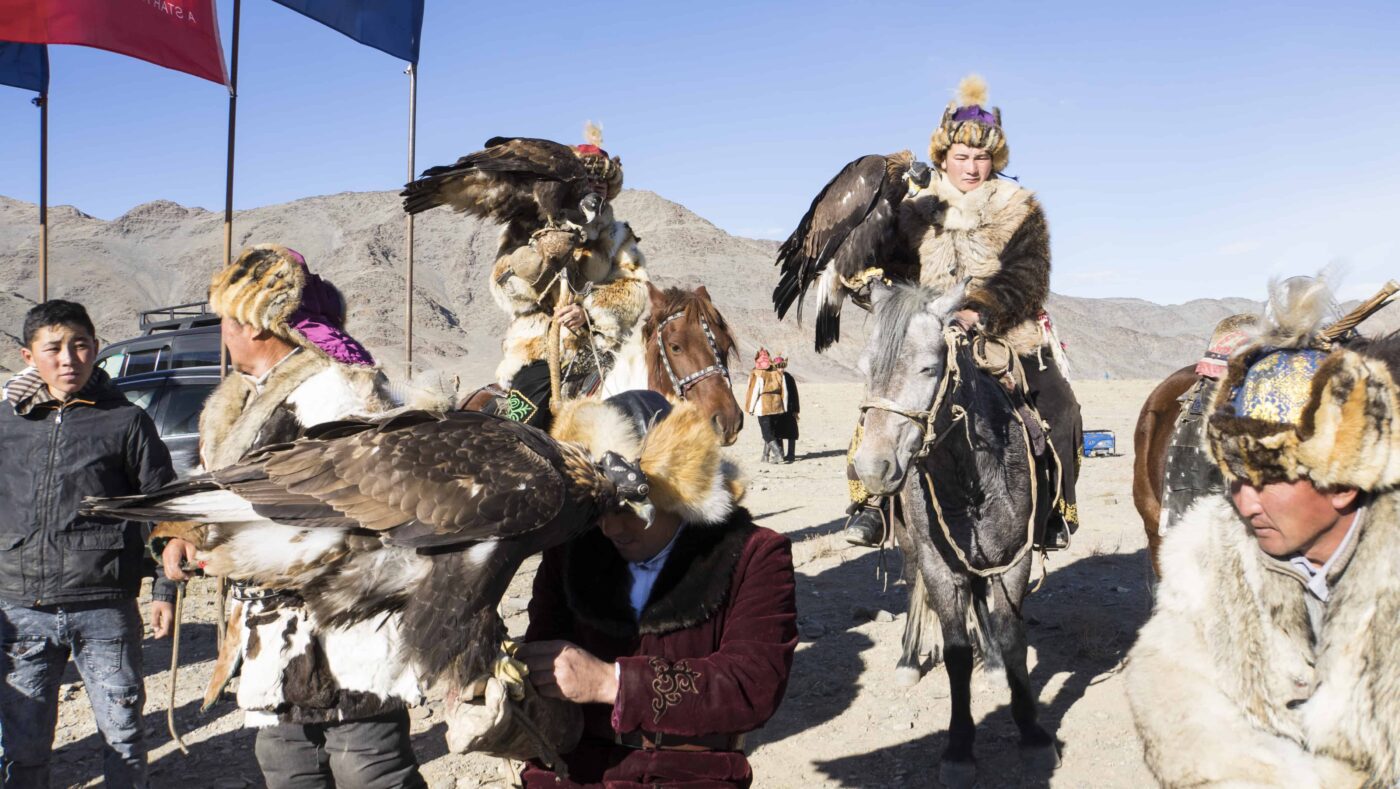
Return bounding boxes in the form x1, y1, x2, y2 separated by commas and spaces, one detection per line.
0, 382, 175, 606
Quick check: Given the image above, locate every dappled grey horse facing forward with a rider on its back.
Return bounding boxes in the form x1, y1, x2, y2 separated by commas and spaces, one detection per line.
853, 283, 1060, 789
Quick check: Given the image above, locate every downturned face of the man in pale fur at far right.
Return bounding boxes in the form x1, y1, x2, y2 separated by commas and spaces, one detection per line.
1231, 480, 1357, 564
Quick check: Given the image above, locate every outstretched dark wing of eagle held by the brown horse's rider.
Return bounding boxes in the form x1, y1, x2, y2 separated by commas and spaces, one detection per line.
399, 137, 588, 225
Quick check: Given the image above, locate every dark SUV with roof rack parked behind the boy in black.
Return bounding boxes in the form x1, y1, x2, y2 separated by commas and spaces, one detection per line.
97, 302, 220, 478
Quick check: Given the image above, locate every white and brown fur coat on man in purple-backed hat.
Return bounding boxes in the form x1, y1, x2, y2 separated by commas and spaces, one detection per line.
199, 348, 423, 726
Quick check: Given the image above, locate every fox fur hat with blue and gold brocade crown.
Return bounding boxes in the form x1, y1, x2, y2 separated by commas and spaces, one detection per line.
1207, 278, 1400, 491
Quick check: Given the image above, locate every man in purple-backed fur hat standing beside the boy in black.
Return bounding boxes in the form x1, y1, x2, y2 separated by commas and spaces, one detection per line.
162, 243, 424, 789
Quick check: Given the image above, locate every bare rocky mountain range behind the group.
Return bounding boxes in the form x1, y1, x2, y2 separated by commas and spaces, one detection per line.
0, 190, 1400, 383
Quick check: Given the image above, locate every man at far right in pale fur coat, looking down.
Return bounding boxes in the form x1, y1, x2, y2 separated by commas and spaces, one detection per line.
1127, 274, 1400, 788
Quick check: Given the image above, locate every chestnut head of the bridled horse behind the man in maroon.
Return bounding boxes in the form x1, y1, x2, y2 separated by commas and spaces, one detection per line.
638, 284, 743, 446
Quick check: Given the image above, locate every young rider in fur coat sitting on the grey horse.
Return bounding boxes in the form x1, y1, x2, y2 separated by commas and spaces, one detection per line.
844, 76, 1084, 550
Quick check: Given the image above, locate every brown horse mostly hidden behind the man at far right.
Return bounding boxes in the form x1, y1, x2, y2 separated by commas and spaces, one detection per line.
1133, 364, 1198, 578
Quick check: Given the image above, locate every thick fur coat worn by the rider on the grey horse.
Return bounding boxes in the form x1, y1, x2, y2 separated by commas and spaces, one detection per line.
899, 171, 1050, 355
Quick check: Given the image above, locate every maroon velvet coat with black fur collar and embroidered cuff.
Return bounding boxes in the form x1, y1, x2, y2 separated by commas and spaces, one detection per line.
524, 509, 797, 788
